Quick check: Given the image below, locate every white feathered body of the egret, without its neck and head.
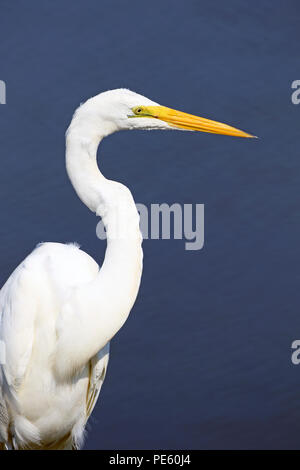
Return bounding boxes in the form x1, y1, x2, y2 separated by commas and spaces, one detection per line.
0, 243, 108, 448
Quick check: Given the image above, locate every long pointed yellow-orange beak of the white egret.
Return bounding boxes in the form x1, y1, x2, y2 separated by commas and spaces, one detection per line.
145, 106, 256, 138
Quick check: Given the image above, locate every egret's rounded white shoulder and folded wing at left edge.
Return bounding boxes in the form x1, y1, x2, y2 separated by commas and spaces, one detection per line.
0, 243, 99, 389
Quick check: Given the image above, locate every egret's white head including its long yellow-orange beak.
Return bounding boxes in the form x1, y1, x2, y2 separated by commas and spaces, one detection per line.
70, 88, 255, 137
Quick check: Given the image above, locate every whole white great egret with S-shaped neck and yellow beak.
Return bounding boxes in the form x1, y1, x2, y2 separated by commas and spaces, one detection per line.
0, 89, 253, 449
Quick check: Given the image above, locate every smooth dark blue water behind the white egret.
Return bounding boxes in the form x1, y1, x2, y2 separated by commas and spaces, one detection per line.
0, 0, 300, 449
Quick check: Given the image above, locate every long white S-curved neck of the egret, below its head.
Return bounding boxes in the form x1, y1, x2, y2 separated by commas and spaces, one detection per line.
61, 119, 143, 372
